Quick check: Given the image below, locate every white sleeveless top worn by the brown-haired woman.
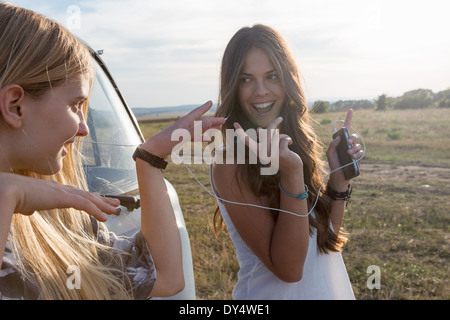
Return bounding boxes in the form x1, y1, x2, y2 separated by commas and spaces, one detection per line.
210, 167, 355, 300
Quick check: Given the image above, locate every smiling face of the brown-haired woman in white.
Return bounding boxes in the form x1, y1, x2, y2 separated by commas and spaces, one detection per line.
238, 47, 284, 128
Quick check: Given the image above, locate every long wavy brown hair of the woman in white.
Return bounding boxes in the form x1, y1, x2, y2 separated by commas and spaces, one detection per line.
213, 24, 346, 253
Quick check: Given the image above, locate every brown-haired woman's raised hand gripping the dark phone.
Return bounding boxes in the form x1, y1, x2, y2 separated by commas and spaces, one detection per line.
326, 109, 363, 192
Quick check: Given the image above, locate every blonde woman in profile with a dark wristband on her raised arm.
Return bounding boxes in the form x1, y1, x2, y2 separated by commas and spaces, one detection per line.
0, 2, 224, 299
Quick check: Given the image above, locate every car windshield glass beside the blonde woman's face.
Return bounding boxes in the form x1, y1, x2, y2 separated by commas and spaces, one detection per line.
82, 63, 142, 195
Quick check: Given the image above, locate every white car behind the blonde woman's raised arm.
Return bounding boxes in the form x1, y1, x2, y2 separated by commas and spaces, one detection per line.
82, 49, 195, 300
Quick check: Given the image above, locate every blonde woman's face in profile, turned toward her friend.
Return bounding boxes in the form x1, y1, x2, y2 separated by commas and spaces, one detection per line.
19, 76, 90, 174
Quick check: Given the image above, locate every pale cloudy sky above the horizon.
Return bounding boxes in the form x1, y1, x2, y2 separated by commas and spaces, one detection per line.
8, 0, 450, 107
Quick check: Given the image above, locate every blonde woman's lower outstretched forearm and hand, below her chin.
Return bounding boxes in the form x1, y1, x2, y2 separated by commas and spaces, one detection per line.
0, 173, 120, 222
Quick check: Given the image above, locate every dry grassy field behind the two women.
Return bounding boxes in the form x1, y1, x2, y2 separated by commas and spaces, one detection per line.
141, 109, 450, 299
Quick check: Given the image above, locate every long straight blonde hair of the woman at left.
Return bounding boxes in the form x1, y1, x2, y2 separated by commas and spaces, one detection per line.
0, 2, 130, 299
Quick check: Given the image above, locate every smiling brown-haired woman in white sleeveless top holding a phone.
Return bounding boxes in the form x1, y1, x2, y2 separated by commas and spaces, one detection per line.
212, 25, 361, 299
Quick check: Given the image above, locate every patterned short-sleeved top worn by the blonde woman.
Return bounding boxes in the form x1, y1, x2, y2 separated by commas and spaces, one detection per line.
0, 219, 156, 300
